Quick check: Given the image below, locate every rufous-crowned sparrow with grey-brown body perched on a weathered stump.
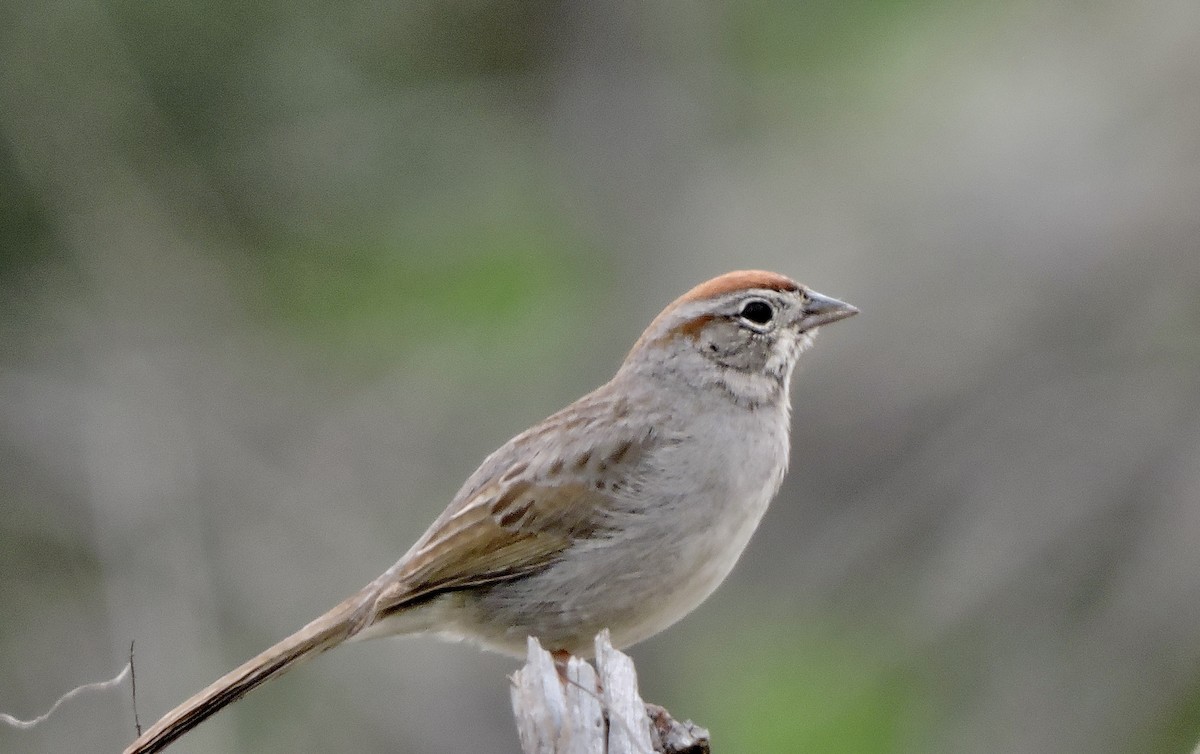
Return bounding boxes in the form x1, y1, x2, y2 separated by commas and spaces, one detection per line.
126, 270, 858, 754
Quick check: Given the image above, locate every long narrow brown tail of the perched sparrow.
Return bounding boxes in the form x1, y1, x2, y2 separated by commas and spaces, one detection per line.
125, 585, 374, 754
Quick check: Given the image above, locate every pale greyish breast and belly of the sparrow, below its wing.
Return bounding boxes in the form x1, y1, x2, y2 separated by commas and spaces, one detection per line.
460, 391, 787, 654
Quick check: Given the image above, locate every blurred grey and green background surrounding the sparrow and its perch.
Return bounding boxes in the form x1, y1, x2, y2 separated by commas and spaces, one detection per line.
0, 0, 1200, 754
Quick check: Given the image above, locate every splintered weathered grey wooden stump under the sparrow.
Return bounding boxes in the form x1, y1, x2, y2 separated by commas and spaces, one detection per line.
511, 630, 709, 754
